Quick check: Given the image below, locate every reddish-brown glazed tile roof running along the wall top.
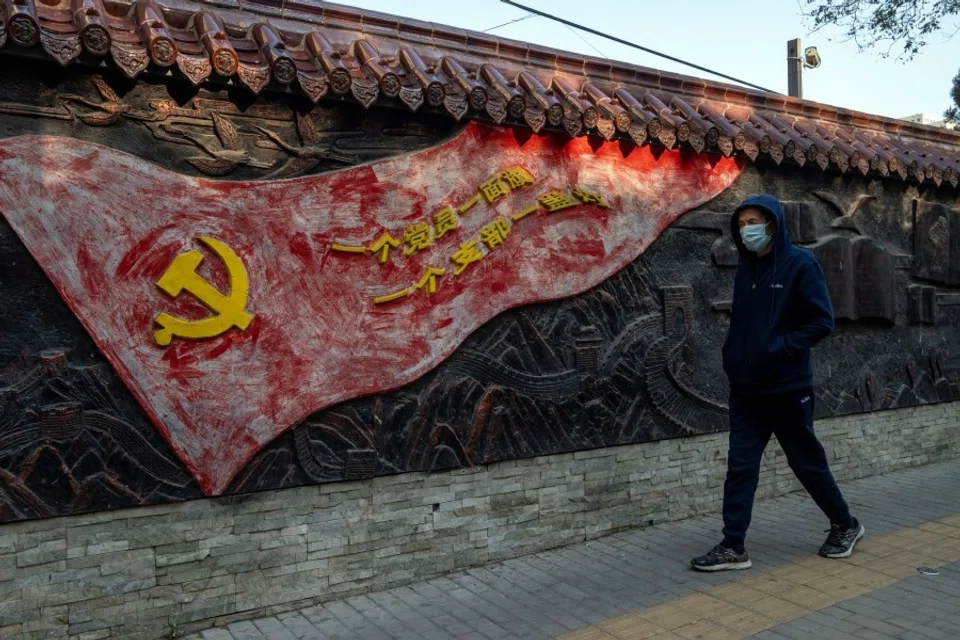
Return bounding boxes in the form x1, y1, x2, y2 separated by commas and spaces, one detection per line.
0, 0, 960, 188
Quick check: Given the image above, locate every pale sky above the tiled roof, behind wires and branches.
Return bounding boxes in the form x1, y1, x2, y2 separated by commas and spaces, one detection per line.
350, 0, 960, 118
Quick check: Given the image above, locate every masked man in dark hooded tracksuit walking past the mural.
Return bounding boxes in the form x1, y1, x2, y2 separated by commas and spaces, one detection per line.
691, 195, 865, 571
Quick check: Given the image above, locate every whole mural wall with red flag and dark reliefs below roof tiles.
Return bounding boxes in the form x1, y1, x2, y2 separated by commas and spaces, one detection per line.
0, 65, 960, 521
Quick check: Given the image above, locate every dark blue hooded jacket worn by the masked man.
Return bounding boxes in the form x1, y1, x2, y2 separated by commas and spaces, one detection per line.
723, 195, 834, 395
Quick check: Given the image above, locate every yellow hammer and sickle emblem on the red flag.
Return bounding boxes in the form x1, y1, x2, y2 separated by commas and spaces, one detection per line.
153, 236, 253, 347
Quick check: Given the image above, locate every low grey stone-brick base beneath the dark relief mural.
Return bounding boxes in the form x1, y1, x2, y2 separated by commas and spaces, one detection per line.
0, 403, 960, 640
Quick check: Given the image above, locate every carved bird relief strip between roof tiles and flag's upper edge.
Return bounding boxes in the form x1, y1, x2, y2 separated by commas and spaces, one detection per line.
0, 66, 455, 179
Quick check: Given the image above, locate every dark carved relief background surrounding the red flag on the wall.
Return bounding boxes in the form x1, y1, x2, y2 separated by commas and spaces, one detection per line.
0, 63, 960, 522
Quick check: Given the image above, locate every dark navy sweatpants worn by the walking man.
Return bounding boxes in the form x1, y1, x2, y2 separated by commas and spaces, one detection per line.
723, 389, 853, 551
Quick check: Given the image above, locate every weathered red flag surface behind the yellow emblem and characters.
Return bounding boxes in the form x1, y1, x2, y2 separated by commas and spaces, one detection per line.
0, 124, 740, 494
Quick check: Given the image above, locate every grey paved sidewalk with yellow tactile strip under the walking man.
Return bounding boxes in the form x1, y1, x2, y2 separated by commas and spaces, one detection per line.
190, 461, 960, 640
